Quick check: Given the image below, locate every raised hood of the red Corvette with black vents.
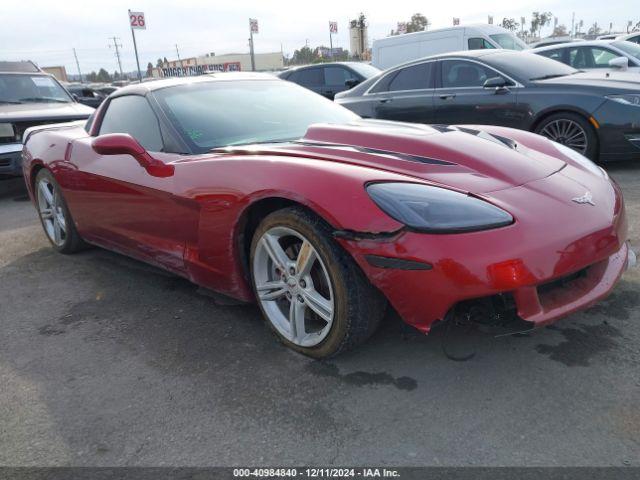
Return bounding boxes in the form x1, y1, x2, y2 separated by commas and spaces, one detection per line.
218, 120, 565, 193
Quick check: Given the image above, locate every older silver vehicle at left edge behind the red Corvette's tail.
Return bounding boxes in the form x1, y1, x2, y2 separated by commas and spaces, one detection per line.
0, 62, 93, 176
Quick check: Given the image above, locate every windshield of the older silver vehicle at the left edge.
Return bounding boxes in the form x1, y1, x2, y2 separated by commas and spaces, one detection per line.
0, 74, 73, 104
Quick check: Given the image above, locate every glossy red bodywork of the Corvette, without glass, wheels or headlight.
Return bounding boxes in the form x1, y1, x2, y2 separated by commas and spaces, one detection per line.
23, 114, 628, 332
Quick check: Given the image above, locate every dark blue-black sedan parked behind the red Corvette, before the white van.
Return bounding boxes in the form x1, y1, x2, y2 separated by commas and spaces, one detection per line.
336, 50, 640, 161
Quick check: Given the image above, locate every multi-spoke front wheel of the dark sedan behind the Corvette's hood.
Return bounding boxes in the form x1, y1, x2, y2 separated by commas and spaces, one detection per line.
535, 112, 598, 161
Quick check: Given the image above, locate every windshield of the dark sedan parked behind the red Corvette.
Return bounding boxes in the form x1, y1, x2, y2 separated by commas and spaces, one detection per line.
482, 50, 578, 82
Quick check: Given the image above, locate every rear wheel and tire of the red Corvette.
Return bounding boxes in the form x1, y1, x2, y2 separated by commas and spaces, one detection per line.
34, 169, 87, 254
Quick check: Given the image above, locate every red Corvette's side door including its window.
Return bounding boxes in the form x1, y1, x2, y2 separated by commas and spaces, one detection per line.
67, 95, 198, 273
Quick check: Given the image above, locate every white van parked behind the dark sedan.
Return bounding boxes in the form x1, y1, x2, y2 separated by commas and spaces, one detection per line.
371, 24, 529, 69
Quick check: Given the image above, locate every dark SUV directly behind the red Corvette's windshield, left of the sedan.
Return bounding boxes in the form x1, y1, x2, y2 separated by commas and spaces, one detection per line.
278, 62, 380, 100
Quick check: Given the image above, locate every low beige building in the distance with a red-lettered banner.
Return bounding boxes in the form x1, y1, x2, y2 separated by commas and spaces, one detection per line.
152, 52, 284, 78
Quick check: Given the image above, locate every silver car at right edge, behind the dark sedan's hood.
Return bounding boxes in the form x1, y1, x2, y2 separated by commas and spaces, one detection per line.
532, 40, 640, 72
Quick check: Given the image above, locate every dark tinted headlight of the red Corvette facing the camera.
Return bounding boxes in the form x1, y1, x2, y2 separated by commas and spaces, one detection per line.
367, 183, 513, 233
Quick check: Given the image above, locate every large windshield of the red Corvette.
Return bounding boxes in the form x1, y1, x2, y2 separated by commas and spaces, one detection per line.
154, 80, 359, 153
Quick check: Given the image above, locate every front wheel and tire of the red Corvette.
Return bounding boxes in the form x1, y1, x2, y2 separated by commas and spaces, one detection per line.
250, 207, 386, 358
